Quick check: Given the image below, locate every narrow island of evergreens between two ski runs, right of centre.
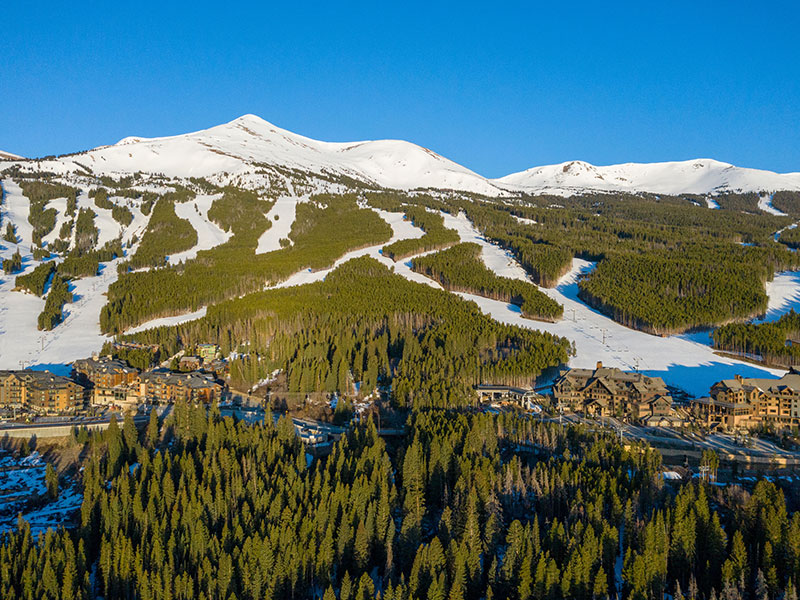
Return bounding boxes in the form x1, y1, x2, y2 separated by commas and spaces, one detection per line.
411, 243, 564, 321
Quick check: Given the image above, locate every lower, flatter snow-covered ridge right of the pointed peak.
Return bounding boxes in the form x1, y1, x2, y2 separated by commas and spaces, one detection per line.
494, 158, 800, 195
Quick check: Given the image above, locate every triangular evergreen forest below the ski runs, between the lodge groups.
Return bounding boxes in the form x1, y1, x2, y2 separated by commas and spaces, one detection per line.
124, 258, 572, 407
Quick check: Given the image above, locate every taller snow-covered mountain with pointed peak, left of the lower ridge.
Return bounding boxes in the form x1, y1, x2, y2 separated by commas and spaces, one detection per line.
21, 115, 503, 195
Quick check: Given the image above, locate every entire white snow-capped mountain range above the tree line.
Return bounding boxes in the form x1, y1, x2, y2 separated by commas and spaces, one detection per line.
6, 115, 800, 196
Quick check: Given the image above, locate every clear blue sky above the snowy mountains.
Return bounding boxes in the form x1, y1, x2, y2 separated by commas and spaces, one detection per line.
0, 0, 800, 177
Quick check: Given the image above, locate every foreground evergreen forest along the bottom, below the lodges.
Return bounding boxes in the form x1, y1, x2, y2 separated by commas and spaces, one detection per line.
0, 404, 800, 600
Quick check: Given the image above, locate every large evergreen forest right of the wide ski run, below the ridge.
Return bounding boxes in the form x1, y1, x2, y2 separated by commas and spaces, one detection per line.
451, 194, 800, 333
